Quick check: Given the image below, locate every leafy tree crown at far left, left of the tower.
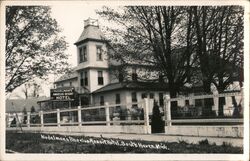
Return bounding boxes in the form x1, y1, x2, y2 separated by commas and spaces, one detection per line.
5, 6, 68, 93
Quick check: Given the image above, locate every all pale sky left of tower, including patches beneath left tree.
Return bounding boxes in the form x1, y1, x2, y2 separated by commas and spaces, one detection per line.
7, 3, 108, 99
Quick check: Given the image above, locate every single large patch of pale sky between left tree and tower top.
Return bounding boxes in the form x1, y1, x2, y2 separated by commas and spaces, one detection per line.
51, 4, 105, 66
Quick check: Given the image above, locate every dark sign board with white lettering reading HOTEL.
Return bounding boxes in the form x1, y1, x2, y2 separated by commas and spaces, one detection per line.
50, 87, 75, 101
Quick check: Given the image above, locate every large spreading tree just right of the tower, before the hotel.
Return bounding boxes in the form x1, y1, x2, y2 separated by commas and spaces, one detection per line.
98, 6, 196, 98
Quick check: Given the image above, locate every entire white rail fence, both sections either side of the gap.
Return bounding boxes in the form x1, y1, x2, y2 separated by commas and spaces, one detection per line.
6, 93, 243, 129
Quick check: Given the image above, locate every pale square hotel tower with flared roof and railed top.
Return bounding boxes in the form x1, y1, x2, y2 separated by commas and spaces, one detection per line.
75, 18, 109, 105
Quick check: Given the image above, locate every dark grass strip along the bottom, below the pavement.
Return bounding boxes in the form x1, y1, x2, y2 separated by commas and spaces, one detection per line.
6, 131, 243, 154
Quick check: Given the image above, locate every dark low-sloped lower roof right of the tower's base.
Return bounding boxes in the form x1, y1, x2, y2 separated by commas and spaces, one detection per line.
92, 81, 168, 94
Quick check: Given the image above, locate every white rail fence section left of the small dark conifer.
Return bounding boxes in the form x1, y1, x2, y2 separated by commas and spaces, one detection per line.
6, 99, 149, 127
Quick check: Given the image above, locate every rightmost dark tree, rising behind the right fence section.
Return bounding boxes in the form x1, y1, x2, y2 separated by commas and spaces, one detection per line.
193, 6, 244, 116
